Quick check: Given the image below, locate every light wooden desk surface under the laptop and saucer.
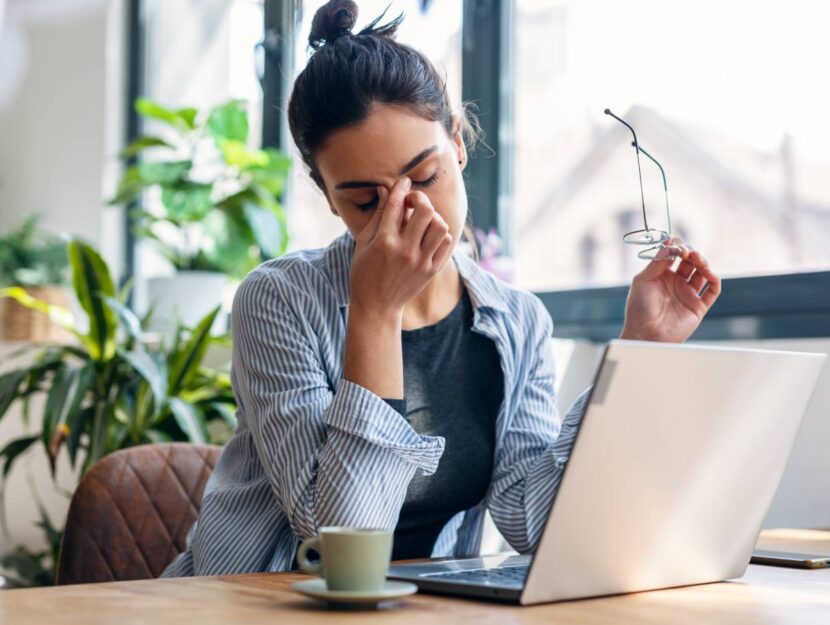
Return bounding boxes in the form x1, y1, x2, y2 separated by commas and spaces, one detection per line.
0, 530, 830, 625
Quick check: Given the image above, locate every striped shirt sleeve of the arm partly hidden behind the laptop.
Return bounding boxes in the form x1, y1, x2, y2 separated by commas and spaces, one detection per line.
489, 294, 591, 553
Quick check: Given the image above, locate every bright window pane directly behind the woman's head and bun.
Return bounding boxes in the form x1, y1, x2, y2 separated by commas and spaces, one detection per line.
284, 0, 462, 254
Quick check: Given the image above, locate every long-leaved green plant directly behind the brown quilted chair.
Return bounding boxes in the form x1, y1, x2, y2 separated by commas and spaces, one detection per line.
0, 241, 236, 583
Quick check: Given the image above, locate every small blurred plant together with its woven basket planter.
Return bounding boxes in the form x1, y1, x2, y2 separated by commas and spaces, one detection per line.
0, 215, 69, 341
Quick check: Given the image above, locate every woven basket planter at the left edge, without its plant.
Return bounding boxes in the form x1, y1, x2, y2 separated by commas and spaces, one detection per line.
0, 286, 71, 343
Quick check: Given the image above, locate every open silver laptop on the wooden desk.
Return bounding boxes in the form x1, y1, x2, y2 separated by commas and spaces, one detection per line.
388, 340, 826, 605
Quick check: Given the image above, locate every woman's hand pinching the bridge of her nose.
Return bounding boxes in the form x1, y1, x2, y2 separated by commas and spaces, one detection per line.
350, 177, 453, 315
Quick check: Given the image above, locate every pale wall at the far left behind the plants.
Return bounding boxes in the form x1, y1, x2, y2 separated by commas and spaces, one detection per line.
0, 0, 124, 554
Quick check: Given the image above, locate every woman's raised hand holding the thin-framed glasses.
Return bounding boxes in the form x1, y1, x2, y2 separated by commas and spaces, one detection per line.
620, 239, 721, 343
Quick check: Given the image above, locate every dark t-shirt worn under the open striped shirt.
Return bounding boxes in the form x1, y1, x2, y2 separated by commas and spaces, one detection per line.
386, 289, 504, 560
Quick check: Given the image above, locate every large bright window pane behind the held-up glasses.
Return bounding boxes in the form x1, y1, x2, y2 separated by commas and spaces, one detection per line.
511, 0, 830, 291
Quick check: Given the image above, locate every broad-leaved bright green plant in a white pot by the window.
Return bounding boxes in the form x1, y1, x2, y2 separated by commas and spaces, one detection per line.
110, 98, 290, 327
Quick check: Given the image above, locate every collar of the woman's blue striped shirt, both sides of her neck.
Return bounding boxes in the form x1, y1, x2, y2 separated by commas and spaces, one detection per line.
325, 230, 508, 313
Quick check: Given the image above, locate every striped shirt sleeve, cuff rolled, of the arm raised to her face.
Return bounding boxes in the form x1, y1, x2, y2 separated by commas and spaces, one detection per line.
231, 272, 444, 539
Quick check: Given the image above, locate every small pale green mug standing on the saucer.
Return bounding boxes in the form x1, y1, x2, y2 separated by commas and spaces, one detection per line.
297, 527, 392, 592
